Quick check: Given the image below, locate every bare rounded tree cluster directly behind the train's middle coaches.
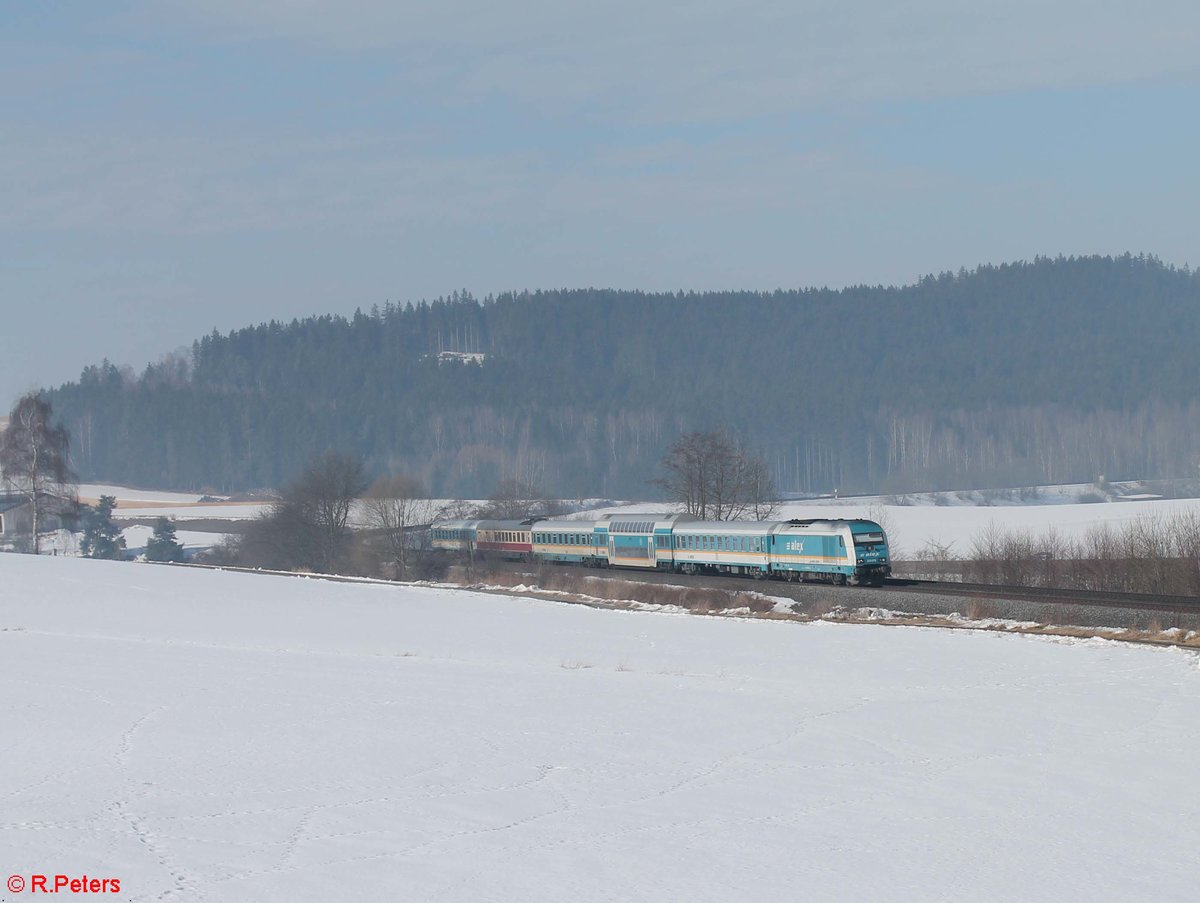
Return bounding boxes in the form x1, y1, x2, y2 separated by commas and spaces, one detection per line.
653, 432, 779, 520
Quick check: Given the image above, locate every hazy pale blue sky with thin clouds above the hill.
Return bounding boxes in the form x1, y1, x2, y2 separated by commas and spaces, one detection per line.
0, 0, 1200, 406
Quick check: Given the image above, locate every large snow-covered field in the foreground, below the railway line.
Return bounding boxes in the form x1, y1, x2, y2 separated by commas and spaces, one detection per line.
0, 555, 1200, 903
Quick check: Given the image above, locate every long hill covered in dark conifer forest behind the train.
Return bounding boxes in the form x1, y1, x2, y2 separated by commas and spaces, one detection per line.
42, 250, 1200, 497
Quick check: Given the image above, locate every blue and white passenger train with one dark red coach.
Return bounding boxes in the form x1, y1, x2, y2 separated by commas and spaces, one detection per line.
430, 514, 892, 586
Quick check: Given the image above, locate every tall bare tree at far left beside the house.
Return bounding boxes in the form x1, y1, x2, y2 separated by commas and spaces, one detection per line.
0, 393, 76, 555
